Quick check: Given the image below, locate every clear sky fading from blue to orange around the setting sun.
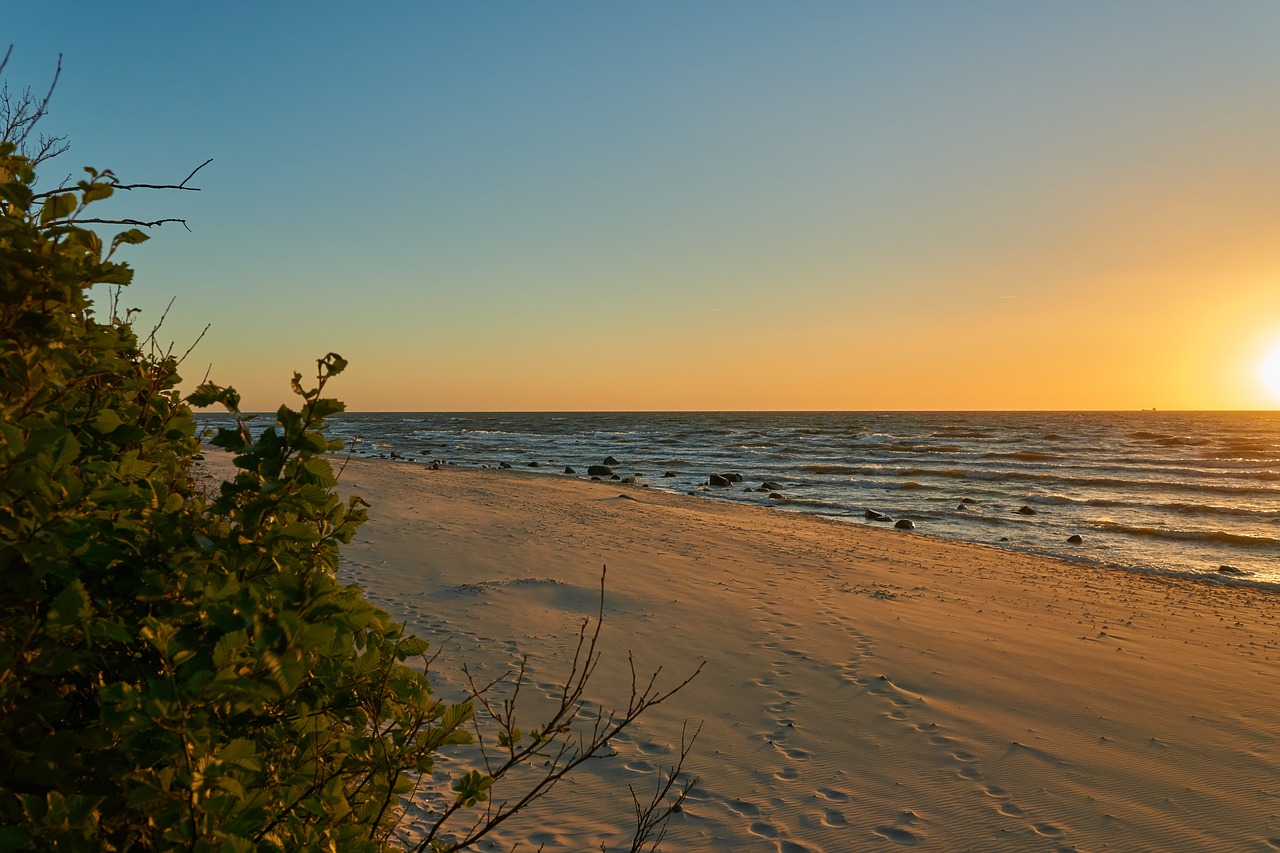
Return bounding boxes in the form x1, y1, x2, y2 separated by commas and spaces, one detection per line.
0, 0, 1280, 411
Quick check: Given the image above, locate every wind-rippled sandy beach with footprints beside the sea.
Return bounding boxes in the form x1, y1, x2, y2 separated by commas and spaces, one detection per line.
202, 456, 1280, 850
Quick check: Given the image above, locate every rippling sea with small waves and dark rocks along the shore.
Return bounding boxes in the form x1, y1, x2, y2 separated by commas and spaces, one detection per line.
200, 411, 1280, 589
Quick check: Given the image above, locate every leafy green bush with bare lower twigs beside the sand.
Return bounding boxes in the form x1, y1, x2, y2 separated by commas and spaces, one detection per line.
0, 133, 692, 853
